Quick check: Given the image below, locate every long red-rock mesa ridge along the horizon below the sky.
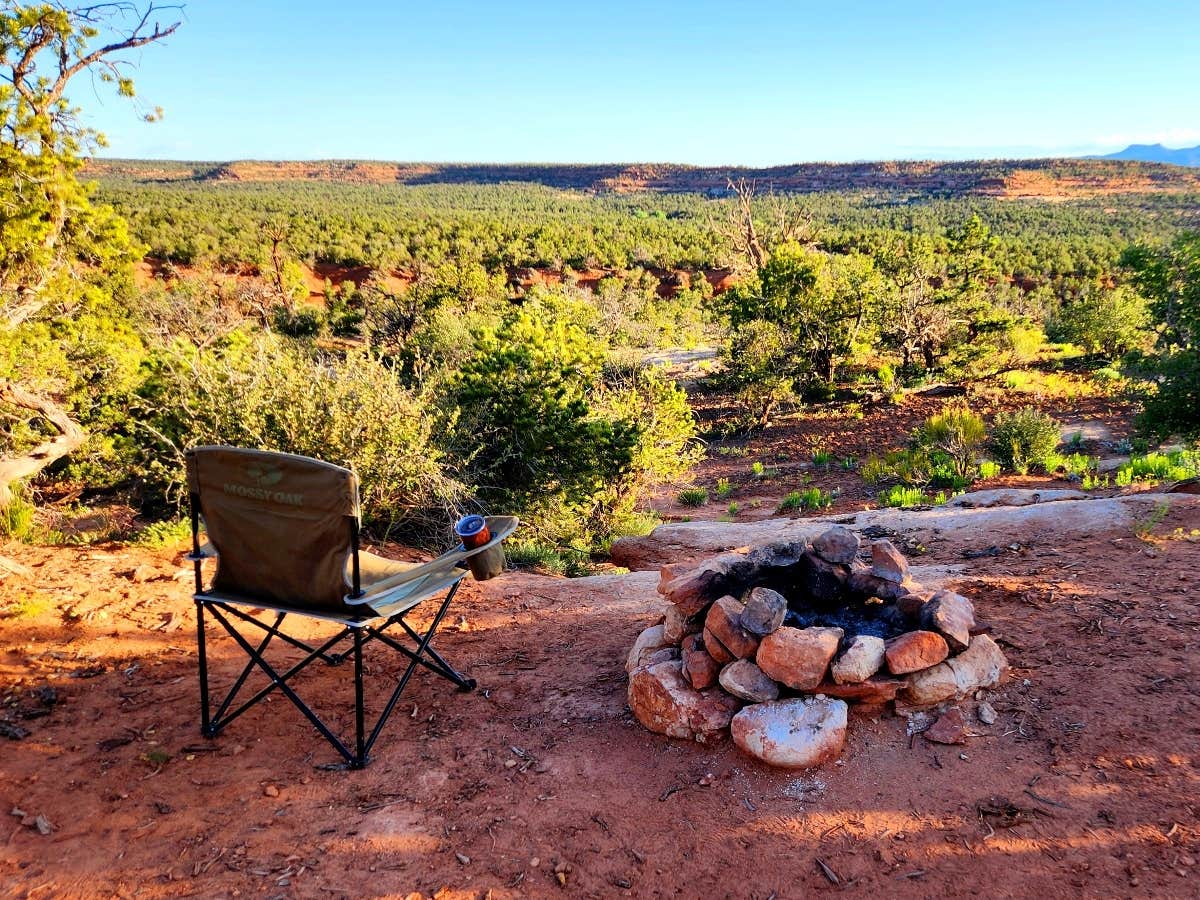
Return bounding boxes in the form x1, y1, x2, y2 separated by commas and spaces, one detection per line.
85, 158, 1200, 200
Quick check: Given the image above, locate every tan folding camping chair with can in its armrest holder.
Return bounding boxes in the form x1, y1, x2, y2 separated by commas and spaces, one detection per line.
186, 446, 517, 769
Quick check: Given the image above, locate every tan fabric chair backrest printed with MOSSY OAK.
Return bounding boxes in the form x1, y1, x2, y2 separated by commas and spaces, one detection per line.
186, 446, 359, 611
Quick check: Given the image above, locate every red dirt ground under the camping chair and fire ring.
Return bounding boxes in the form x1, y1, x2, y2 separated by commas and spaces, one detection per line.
0, 501, 1200, 900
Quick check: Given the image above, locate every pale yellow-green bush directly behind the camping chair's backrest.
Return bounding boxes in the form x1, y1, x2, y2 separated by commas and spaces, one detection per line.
131, 332, 466, 544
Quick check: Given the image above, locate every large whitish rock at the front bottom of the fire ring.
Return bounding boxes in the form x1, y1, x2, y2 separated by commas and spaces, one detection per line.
730, 697, 848, 768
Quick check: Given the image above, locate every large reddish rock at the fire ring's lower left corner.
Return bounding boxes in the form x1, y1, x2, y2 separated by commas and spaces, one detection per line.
629, 662, 742, 744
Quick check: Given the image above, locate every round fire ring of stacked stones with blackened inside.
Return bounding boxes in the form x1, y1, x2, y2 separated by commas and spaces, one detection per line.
625, 526, 1008, 768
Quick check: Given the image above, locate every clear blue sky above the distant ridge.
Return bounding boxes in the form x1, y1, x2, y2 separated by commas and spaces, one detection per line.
84, 0, 1200, 164
